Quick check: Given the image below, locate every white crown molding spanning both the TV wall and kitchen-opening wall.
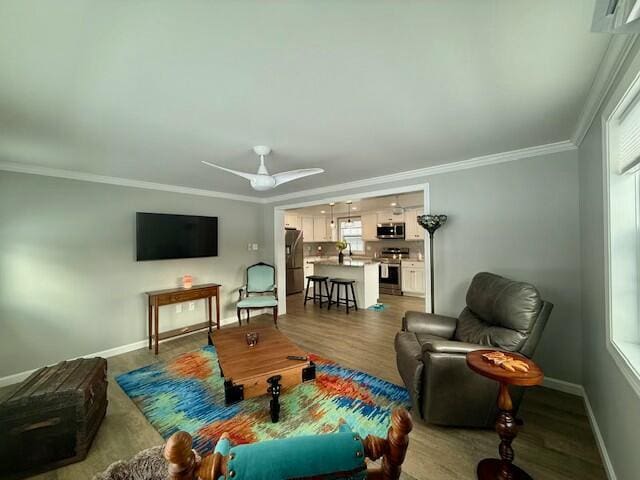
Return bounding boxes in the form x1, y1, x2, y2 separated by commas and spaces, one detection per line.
0, 140, 576, 204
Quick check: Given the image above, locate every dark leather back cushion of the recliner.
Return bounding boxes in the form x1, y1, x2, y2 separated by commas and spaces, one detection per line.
454, 272, 542, 351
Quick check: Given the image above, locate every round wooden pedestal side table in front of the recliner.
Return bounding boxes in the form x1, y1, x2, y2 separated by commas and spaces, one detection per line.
467, 350, 544, 480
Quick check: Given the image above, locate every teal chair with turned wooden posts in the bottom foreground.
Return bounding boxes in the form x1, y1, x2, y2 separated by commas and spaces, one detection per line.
164, 408, 413, 480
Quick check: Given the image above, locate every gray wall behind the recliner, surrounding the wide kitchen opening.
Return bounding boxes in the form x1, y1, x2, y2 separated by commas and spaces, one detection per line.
263, 150, 582, 383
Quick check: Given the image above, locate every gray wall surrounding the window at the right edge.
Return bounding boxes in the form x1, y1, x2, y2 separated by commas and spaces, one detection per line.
578, 42, 640, 480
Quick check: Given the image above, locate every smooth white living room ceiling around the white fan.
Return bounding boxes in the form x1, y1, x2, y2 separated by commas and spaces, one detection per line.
0, 0, 610, 196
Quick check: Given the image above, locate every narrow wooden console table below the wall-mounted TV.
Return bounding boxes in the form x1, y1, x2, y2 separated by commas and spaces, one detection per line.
146, 283, 220, 355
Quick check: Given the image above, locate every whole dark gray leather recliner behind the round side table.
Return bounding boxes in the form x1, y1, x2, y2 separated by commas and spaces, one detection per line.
395, 272, 553, 427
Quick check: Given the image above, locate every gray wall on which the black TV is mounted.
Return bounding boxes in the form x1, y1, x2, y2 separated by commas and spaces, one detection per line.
0, 172, 263, 377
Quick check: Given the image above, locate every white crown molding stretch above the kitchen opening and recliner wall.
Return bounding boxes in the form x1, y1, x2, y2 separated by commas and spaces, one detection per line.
263, 140, 577, 203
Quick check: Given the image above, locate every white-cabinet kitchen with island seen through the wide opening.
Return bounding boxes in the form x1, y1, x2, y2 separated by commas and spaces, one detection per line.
285, 192, 426, 308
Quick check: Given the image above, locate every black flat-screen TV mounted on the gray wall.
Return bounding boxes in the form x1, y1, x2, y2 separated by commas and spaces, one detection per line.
136, 212, 218, 261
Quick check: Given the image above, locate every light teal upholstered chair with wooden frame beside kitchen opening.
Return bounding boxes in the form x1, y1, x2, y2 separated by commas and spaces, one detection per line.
236, 262, 278, 327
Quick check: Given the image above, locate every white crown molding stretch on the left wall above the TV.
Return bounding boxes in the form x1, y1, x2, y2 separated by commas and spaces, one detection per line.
0, 162, 264, 203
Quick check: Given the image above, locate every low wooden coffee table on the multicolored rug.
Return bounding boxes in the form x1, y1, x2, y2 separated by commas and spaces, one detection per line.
209, 326, 316, 405
